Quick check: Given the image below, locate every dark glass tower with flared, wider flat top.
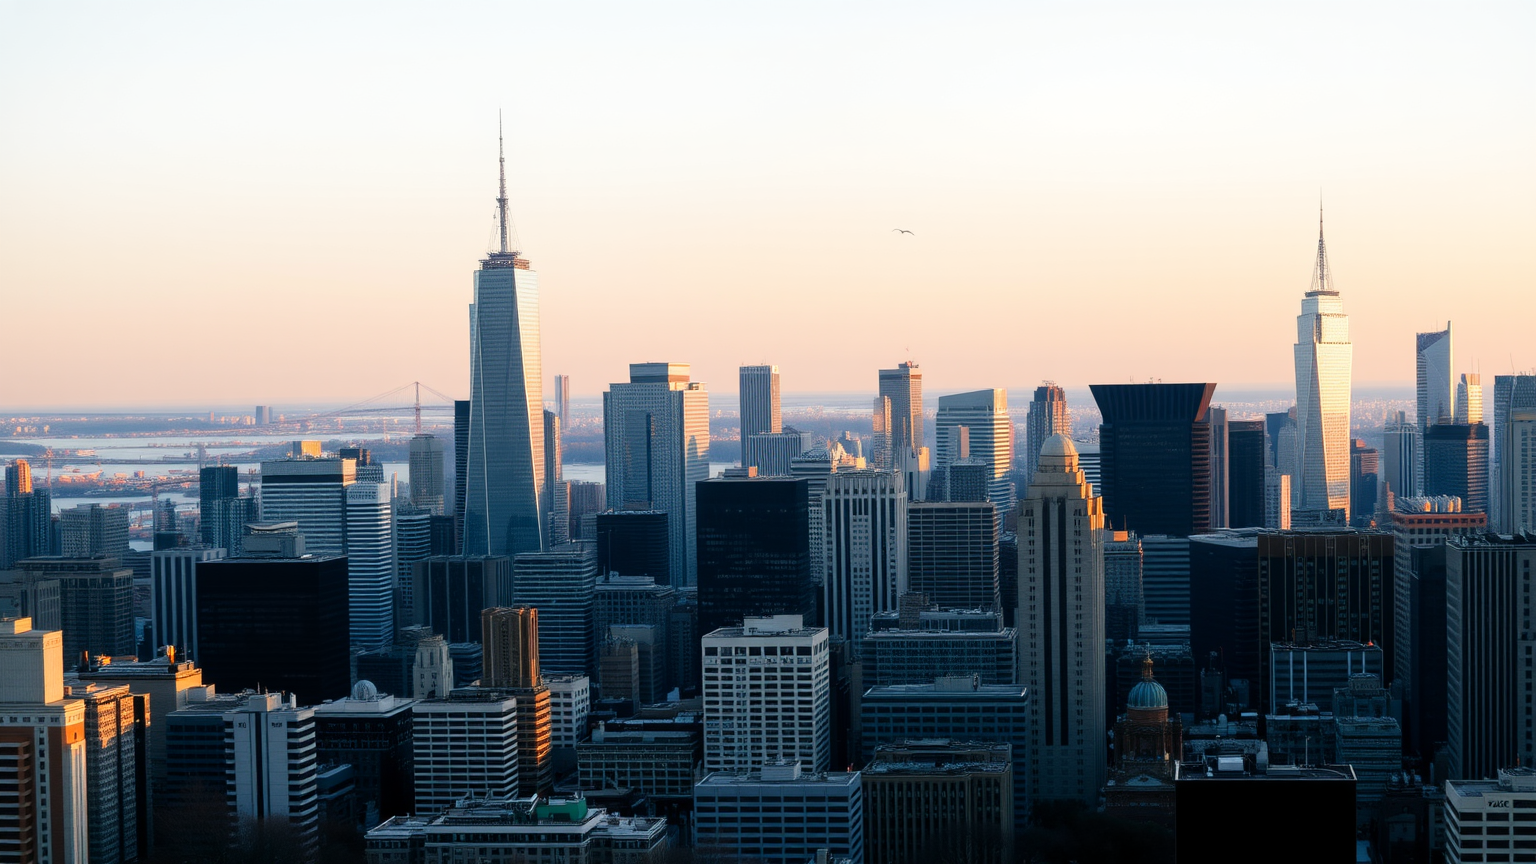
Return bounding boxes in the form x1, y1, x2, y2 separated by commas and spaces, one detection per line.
1089, 384, 1217, 537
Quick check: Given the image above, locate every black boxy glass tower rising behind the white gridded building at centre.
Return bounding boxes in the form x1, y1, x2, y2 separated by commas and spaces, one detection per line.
697, 477, 816, 633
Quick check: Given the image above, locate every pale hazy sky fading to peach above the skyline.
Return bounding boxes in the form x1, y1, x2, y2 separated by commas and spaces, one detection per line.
0, 0, 1536, 409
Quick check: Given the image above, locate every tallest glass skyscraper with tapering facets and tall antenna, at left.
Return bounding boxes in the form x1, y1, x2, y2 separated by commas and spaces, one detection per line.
464, 126, 548, 555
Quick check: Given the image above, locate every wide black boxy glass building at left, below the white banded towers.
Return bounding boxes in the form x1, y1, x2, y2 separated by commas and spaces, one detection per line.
197, 555, 352, 704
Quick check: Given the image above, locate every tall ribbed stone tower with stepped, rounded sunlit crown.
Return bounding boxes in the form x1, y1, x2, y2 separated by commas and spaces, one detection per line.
1017, 433, 1105, 806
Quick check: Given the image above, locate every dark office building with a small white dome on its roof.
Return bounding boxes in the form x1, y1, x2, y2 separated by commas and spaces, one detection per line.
315, 680, 416, 826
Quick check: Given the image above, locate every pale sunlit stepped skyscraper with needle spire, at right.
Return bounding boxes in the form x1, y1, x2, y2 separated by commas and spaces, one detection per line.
1292, 209, 1351, 510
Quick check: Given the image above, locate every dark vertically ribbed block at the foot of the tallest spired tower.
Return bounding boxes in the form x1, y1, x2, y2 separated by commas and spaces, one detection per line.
412, 555, 513, 643
